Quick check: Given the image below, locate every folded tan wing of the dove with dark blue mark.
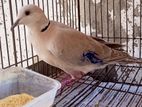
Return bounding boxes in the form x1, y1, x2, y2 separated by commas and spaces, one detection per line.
48, 27, 115, 65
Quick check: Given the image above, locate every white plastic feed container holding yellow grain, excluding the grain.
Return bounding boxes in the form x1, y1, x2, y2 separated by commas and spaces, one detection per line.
0, 67, 61, 107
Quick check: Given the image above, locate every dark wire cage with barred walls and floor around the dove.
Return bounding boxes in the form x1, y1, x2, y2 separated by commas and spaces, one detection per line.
0, 0, 142, 107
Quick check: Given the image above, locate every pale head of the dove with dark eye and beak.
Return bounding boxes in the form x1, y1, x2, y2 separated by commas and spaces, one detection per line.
11, 5, 47, 30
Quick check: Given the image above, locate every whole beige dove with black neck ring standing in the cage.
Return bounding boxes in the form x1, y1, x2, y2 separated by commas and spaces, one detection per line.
11, 4, 142, 87
